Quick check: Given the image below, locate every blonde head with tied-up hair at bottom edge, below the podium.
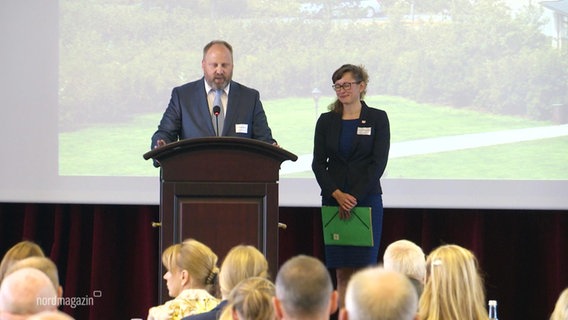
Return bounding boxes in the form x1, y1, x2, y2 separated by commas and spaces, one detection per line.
220, 277, 277, 320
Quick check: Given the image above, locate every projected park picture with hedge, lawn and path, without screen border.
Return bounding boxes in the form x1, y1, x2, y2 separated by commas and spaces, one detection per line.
59, 0, 568, 180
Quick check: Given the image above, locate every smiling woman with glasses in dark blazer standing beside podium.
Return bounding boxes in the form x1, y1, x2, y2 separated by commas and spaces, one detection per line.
312, 64, 390, 306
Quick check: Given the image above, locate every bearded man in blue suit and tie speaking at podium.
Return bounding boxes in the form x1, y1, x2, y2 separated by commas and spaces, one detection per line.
151, 40, 276, 162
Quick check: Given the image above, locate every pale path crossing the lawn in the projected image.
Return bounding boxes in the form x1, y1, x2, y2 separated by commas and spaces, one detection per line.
280, 124, 568, 174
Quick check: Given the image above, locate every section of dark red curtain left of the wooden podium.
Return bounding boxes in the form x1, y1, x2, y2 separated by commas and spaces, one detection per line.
0, 204, 161, 320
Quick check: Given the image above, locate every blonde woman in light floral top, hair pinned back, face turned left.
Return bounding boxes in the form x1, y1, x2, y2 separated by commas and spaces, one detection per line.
148, 239, 219, 320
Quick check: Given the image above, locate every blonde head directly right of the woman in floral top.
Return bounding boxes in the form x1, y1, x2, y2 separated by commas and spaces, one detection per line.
219, 245, 270, 299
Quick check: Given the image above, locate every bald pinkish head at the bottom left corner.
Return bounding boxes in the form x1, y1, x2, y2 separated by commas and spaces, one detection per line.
0, 268, 57, 316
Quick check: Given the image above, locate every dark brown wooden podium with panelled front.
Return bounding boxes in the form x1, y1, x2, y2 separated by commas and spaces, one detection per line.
144, 137, 298, 303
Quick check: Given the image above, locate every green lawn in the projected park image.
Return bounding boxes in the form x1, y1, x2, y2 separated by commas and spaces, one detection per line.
59, 96, 568, 179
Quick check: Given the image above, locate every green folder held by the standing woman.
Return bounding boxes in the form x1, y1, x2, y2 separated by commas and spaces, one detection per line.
321, 206, 373, 247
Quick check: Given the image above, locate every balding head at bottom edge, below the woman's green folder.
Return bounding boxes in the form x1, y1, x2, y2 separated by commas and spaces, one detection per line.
339, 267, 418, 320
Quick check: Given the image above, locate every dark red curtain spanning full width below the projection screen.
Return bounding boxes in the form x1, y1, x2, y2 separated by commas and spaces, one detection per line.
0, 203, 568, 319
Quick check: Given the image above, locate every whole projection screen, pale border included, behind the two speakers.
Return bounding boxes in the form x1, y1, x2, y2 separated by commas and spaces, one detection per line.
0, 0, 568, 209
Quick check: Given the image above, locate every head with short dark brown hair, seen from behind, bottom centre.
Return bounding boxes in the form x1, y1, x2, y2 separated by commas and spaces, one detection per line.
274, 255, 337, 319
